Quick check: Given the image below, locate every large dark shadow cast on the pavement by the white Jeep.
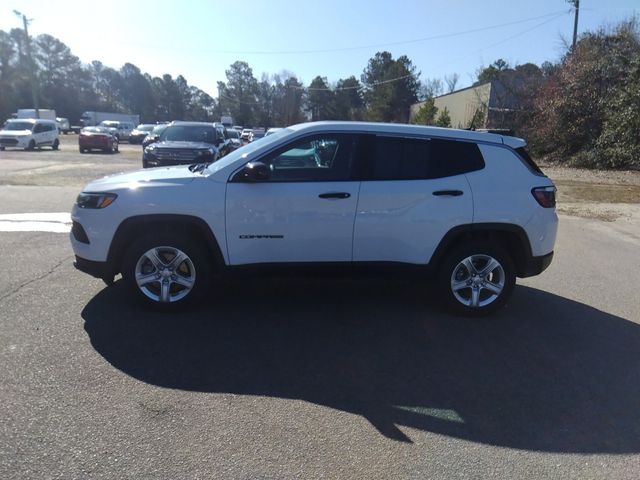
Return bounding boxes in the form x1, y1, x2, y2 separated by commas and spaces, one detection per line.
82, 278, 640, 453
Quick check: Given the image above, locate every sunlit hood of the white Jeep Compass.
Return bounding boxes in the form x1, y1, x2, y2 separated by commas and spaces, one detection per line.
82, 165, 201, 192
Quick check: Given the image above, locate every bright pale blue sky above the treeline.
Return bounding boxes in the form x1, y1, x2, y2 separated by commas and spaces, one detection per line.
0, 0, 640, 97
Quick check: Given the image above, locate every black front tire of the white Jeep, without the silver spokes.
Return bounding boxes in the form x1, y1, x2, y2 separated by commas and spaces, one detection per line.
122, 231, 213, 311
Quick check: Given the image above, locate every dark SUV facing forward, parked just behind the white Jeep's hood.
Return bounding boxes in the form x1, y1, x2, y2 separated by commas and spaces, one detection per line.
142, 121, 230, 168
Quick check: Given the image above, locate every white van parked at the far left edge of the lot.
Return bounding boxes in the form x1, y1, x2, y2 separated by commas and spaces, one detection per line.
0, 118, 60, 150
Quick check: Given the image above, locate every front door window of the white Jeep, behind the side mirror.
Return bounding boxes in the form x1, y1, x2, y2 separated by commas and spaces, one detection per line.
261, 134, 357, 182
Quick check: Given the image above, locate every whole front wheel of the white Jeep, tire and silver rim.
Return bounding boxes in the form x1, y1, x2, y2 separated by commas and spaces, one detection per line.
123, 234, 210, 310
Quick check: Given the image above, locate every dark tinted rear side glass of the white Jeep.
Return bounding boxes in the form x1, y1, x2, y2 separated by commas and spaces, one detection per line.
365, 137, 484, 180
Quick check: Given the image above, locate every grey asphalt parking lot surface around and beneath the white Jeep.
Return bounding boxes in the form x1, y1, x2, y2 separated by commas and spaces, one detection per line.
0, 136, 640, 479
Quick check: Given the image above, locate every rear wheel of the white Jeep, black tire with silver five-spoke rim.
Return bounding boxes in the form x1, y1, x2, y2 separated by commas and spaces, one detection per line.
437, 241, 516, 317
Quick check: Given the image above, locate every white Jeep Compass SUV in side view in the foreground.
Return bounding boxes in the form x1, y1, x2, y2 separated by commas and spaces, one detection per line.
71, 122, 558, 315
